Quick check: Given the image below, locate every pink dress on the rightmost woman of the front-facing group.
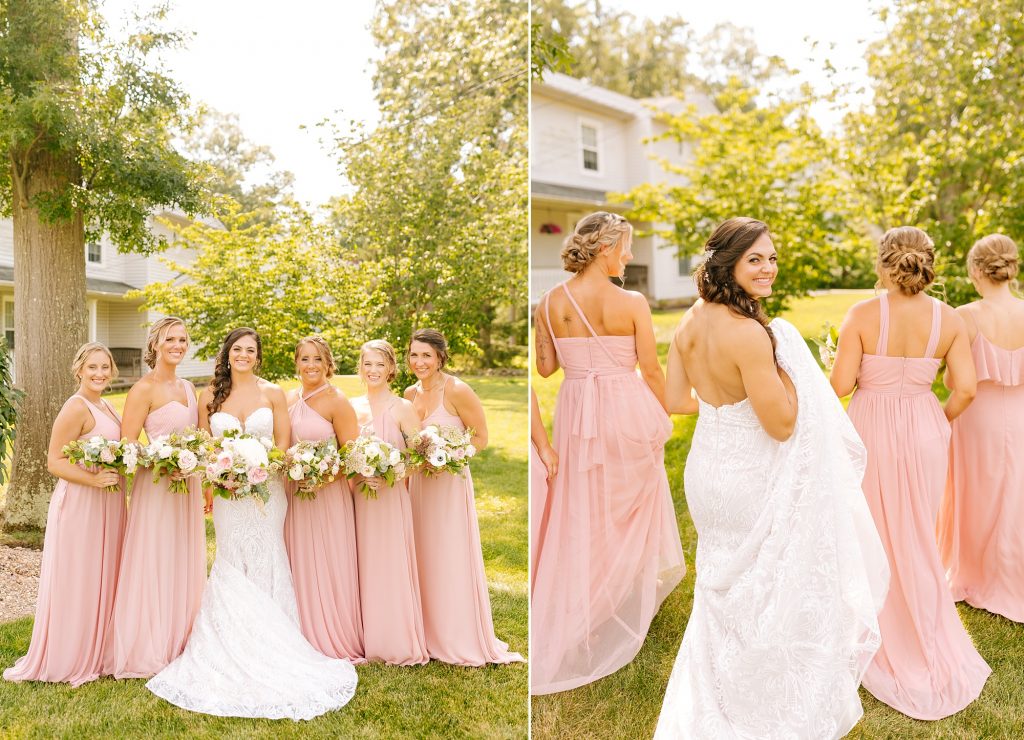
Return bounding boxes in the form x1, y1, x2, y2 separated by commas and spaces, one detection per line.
409, 379, 522, 665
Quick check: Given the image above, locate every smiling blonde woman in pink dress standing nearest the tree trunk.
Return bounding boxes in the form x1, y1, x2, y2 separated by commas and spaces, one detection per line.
3, 342, 125, 686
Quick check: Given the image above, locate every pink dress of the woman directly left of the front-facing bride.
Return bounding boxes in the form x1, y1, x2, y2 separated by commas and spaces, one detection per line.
103, 383, 206, 679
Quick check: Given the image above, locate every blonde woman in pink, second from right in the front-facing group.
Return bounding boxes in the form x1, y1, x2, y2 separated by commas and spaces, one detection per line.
352, 339, 430, 665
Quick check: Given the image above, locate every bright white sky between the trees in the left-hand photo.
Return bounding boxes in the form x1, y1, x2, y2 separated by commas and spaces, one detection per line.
101, 0, 377, 206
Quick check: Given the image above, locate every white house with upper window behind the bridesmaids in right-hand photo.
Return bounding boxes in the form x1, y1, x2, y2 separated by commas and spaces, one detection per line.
529, 73, 714, 304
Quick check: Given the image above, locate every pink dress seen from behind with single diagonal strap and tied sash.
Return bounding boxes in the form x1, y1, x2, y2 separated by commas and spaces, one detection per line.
530, 284, 686, 694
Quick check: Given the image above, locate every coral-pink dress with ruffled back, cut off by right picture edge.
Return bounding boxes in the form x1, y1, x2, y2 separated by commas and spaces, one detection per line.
938, 334, 1024, 622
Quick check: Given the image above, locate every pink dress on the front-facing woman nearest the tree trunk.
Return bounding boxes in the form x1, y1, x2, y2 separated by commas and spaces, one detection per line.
3, 395, 125, 686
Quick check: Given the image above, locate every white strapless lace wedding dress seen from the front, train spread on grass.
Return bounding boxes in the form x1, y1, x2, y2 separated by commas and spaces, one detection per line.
145, 407, 356, 720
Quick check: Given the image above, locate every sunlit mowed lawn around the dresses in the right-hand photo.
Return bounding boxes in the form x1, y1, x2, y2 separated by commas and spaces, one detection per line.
531, 291, 1024, 740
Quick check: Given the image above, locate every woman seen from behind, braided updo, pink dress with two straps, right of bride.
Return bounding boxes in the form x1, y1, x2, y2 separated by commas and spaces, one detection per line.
831, 226, 991, 720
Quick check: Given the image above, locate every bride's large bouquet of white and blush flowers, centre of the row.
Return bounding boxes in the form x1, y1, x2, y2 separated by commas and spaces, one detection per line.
204, 429, 285, 504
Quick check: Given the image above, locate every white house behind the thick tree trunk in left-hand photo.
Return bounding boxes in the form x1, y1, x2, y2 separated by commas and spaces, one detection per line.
0, 212, 214, 385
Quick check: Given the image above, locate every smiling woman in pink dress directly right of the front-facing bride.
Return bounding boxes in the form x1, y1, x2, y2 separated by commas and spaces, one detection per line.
285, 335, 366, 663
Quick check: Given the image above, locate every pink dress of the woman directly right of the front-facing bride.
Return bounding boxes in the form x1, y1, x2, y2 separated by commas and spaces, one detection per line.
285, 385, 366, 663
